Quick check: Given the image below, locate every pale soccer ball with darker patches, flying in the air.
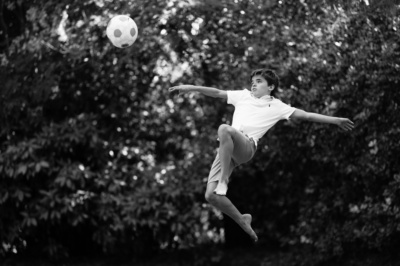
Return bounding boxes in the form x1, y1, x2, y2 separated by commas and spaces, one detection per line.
106, 15, 138, 48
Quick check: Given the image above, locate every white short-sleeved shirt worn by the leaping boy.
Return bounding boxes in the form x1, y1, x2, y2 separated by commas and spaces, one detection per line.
227, 89, 296, 145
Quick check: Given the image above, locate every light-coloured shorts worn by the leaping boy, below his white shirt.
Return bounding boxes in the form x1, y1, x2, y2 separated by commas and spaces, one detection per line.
207, 129, 257, 184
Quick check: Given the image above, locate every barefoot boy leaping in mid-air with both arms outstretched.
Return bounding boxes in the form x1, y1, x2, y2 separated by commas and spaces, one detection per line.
169, 69, 354, 241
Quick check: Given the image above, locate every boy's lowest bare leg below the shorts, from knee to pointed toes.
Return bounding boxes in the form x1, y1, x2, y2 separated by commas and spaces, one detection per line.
205, 182, 258, 242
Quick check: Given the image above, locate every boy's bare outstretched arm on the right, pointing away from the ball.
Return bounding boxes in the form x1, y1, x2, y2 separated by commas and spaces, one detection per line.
290, 109, 354, 131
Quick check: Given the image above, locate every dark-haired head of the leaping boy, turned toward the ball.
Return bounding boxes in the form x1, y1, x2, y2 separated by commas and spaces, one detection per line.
250, 68, 279, 97
